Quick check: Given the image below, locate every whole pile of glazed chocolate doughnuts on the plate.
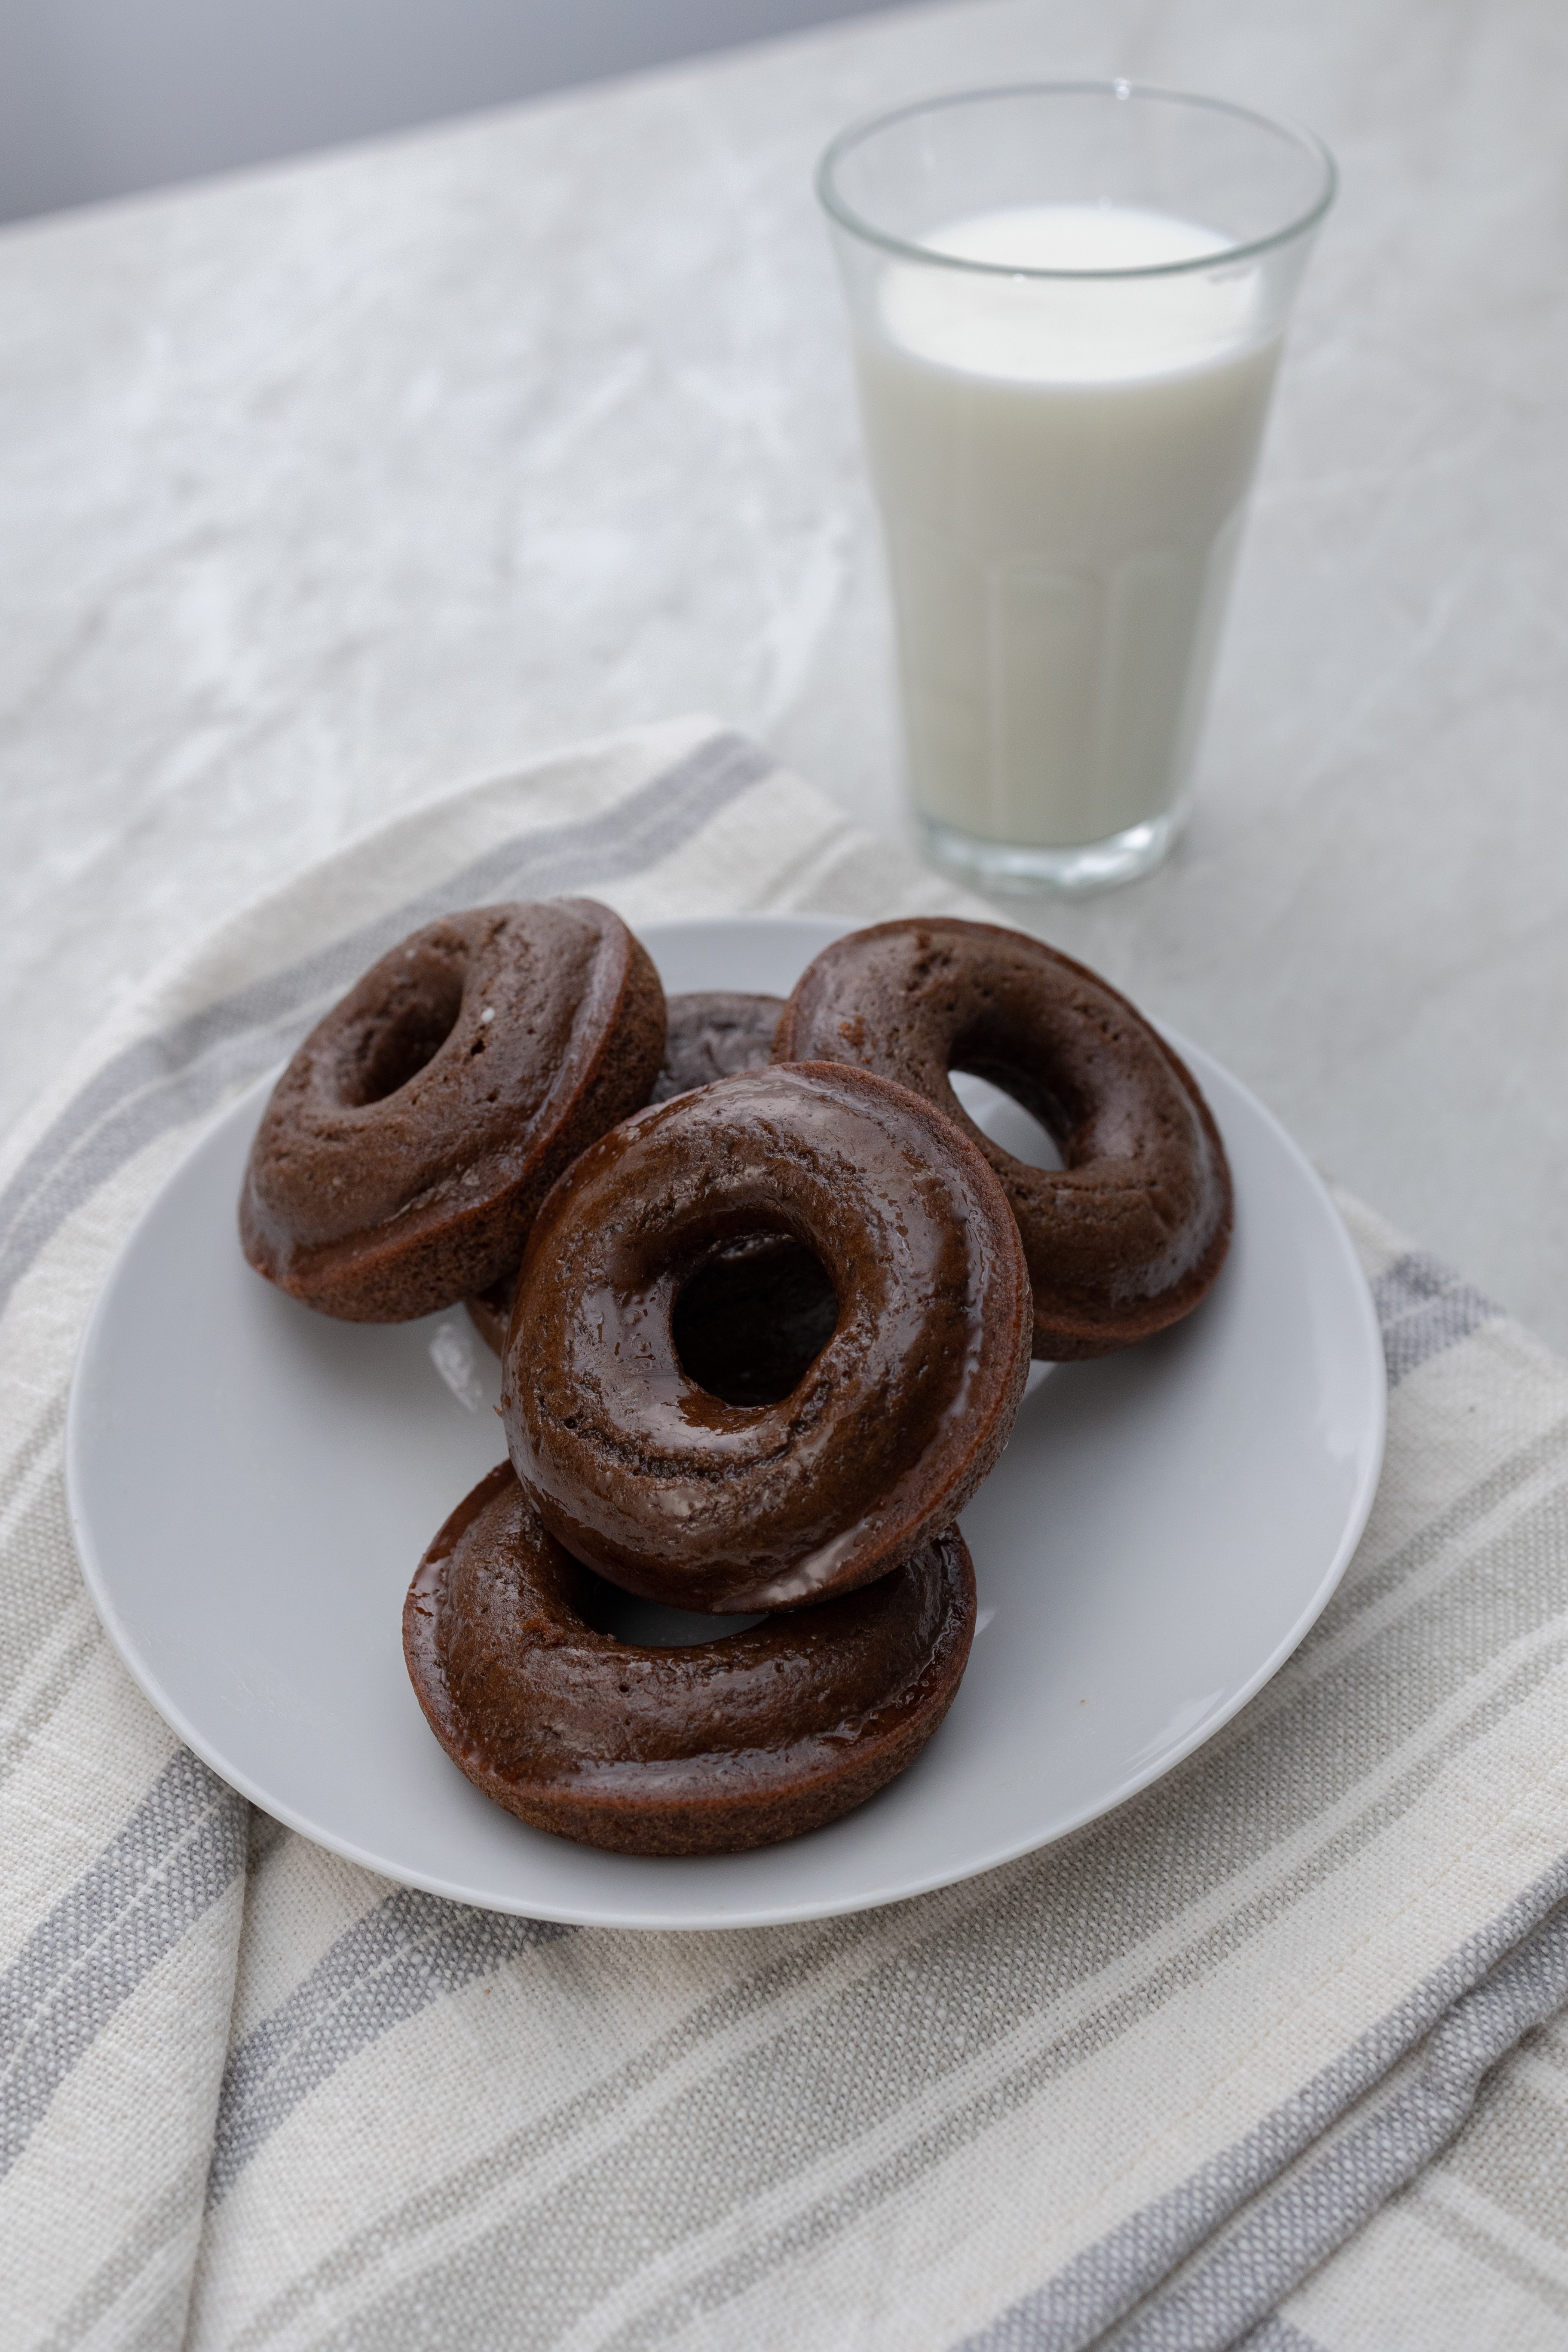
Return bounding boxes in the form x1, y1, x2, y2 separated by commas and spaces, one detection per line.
240, 898, 1232, 1853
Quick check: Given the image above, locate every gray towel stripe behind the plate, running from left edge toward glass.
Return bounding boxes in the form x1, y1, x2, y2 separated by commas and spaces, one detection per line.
0, 734, 773, 1310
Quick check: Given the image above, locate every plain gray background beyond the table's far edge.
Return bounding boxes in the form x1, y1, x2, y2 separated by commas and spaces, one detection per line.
0, 0, 907, 221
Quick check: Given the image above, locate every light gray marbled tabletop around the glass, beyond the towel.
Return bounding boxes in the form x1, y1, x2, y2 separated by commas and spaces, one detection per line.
0, 0, 1568, 1345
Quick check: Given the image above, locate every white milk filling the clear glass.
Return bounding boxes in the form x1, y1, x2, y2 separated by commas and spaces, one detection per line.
856, 205, 1279, 847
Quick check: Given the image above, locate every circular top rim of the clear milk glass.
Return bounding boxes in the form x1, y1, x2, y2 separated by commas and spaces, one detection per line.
816, 75, 1340, 280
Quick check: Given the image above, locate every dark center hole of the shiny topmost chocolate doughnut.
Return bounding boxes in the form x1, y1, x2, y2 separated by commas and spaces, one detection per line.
670, 1232, 839, 1406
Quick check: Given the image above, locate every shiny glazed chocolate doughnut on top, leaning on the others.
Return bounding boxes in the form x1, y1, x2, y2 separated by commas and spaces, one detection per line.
501, 1063, 1030, 1611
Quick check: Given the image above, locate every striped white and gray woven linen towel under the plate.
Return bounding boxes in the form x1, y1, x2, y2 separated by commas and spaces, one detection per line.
0, 722, 1568, 2352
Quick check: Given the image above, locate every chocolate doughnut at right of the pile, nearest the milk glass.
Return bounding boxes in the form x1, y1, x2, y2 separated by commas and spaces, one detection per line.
773, 915, 1232, 1360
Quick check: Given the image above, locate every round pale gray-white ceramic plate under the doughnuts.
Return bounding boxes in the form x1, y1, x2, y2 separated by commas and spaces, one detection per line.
66, 917, 1384, 1929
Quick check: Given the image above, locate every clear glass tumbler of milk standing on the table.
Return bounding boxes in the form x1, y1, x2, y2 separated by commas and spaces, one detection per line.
818, 83, 1335, 891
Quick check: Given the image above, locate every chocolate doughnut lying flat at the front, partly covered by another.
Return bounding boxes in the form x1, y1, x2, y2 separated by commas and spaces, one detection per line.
402, 1463, 976, 1853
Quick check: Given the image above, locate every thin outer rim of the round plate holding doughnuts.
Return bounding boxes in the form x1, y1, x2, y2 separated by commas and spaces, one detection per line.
64, 910, 1387, 1933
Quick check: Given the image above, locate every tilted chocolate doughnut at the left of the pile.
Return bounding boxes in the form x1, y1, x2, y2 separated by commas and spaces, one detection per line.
240, 898, 665, 1322
